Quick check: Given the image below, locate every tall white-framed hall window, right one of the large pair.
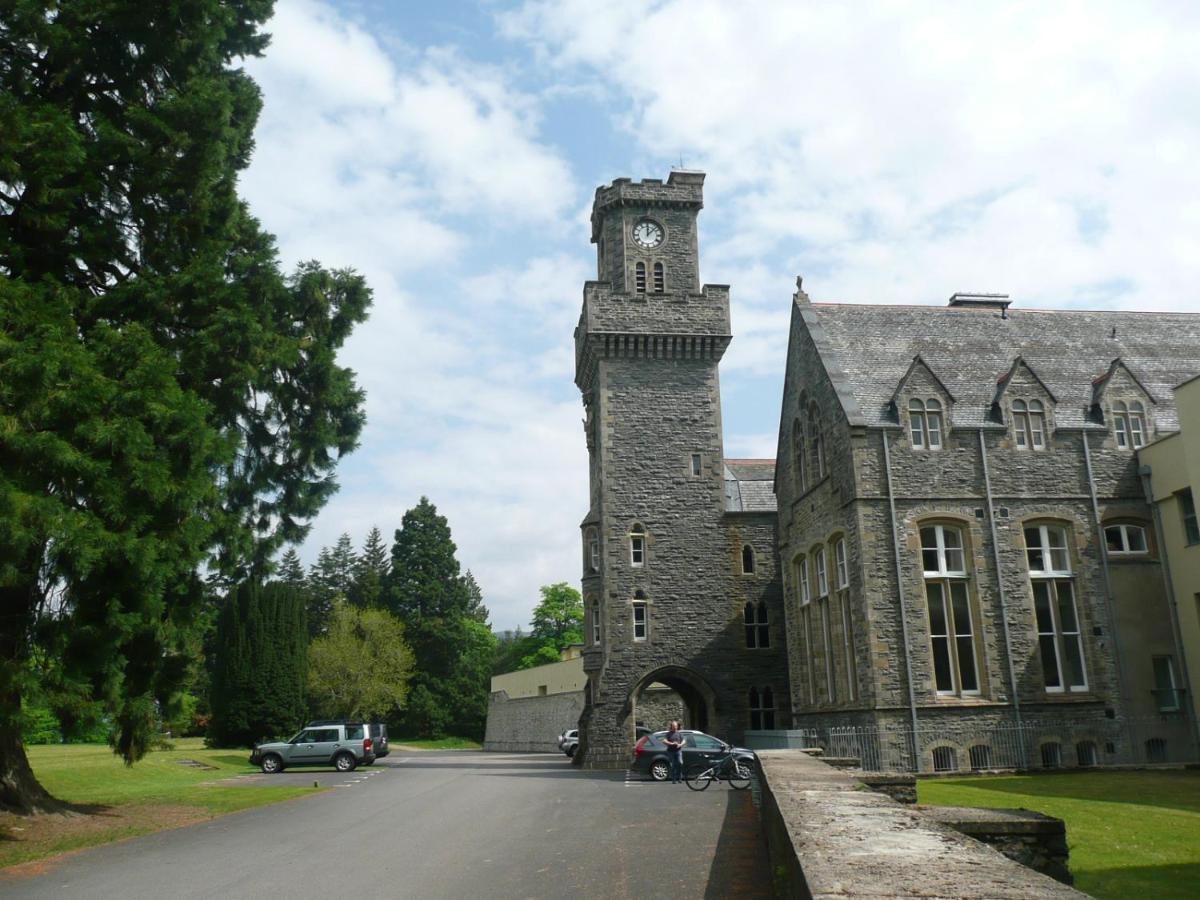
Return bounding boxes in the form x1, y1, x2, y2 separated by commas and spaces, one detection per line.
1025, 524, 1087, 694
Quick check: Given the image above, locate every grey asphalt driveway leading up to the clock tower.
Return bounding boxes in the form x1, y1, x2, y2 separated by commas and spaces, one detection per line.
0, 751, 770, 900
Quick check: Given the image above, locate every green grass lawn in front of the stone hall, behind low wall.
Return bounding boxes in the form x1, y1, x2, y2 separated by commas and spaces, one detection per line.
918, 770, 1200, 900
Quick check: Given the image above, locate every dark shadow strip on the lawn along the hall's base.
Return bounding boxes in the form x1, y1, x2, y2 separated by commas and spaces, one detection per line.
929, 769, 1200, 812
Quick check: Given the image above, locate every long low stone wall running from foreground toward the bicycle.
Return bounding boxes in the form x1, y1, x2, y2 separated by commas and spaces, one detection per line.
758, 750, 1086, 900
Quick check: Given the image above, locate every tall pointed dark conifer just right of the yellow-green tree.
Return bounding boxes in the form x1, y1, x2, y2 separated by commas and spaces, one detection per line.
385, 497, 494, 737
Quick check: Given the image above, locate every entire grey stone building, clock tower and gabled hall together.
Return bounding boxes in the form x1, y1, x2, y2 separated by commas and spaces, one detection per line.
549, 170, 1200, 770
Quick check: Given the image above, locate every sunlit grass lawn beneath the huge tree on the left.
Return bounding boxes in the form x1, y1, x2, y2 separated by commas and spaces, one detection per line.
0, 738, 313, 866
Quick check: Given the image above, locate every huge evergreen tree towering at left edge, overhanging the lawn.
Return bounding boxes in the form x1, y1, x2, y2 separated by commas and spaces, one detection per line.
0, 0, 370, 810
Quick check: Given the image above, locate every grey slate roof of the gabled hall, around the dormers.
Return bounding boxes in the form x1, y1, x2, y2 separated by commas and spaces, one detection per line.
798, 302, 1200, 432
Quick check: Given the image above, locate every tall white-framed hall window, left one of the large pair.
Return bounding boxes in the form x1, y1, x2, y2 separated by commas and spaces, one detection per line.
920, 524, 979, 695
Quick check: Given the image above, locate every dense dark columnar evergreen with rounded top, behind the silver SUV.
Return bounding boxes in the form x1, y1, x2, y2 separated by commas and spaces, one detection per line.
209, 582, 308, 746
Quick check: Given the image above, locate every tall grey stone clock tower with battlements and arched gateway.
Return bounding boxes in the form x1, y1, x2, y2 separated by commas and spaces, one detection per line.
575, 170, 787, 767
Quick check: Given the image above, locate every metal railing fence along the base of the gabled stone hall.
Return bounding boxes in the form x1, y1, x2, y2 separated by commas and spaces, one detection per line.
758, 716, 1198, 772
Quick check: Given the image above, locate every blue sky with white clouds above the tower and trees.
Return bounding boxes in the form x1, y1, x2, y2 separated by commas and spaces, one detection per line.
241, 0, 1200, 628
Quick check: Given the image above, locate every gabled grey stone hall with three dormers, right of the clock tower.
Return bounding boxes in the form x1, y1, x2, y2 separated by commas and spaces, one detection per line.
775, 289, 1200, 770
